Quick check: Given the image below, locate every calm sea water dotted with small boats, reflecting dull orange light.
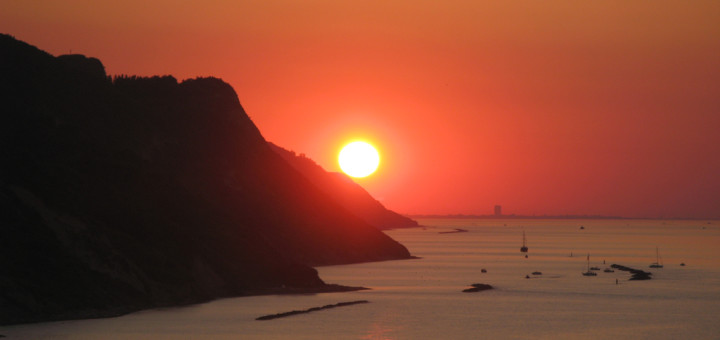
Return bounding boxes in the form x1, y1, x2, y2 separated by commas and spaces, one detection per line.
0, 219, 720, 339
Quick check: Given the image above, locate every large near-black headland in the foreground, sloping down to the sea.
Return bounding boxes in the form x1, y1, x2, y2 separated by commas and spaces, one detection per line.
0, 35, 410, 324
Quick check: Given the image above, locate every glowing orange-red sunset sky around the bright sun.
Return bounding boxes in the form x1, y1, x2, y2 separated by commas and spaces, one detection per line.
0, 0, 720, 218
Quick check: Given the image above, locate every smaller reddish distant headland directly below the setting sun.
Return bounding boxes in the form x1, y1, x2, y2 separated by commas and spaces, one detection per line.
269, 142, 418, 230
